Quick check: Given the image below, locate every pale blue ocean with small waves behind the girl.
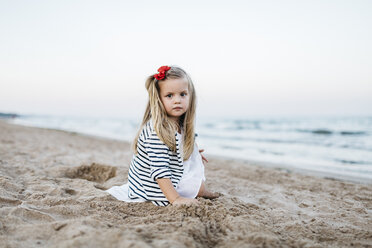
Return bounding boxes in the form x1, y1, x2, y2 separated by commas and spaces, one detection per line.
10, 115, 372, 182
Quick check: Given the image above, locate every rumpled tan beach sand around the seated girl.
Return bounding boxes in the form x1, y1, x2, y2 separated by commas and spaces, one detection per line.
0, 121, 372, 248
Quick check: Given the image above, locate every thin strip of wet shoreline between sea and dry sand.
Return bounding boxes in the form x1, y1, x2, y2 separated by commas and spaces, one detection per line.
0, 119, 372, 185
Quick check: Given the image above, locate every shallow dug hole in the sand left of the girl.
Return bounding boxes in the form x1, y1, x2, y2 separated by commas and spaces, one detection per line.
66, 163, 116, 183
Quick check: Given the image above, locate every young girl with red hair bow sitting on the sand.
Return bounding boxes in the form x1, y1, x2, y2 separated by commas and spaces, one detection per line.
106, 66, 219, 206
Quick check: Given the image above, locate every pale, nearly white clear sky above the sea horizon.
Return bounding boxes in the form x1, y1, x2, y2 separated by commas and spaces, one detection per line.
0, 0, 372, 118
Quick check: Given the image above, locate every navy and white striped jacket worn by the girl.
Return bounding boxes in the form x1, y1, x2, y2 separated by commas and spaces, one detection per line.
128, 120, 183, 206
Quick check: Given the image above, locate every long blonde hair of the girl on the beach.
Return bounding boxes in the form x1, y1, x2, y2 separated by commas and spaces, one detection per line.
133, 66, 196, 160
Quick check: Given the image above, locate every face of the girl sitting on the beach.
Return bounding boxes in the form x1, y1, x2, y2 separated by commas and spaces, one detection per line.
158, 78, 190, 121
